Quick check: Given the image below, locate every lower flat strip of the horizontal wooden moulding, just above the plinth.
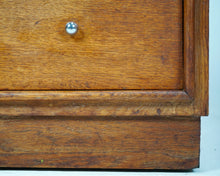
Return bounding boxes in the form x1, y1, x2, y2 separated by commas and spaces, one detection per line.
0, 101, 195, 118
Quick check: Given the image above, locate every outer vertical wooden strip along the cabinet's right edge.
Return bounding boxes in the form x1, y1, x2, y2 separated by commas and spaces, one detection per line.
194, 0, 209, 116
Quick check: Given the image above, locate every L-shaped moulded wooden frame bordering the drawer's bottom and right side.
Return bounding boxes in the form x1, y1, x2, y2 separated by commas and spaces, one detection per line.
0, 0, 209, 116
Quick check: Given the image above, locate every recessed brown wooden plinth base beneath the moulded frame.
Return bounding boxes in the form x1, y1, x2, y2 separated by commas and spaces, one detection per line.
0, 117, 200, 169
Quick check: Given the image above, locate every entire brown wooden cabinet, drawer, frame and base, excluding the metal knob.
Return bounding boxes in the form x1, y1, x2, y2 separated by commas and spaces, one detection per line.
0, 0, 209, 170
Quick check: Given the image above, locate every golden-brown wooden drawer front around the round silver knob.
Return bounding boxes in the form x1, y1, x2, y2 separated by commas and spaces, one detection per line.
0, 0, 184, 90
